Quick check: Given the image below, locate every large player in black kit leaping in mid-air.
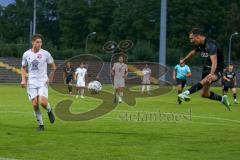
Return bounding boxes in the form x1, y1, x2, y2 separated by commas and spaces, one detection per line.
178, 28, 230, 110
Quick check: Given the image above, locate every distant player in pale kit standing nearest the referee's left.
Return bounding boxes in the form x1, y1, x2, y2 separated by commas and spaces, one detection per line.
142, 64, 152, 94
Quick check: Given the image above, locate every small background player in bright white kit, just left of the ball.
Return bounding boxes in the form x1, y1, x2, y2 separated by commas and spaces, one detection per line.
75, 63, 87, 98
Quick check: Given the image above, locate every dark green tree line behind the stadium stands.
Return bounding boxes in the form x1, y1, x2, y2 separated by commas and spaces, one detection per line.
0, 0, 240, 65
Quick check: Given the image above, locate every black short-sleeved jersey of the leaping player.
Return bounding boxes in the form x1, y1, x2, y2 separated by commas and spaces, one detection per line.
195, 38, 225, 72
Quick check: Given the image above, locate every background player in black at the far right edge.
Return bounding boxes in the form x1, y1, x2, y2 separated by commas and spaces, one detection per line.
223, 64, 238, 104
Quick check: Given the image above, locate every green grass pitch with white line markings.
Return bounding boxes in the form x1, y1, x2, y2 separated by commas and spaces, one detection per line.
0, 85, 240, 160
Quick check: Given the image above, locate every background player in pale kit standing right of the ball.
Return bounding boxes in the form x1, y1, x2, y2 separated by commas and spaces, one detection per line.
112, 55, 128, 103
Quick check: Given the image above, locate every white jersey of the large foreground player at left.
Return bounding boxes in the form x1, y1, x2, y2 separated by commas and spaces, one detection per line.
22, 49, 53, 87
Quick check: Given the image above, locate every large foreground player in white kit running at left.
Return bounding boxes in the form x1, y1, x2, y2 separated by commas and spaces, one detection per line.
21, 34, 56, 131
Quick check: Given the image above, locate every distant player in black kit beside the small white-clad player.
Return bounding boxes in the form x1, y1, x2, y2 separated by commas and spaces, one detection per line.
63, 62, 75, 95
